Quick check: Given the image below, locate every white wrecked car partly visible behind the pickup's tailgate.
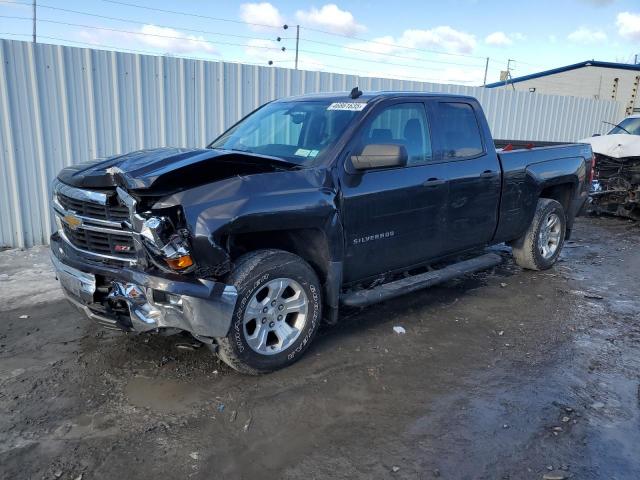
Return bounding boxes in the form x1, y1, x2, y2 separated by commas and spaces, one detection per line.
580, 115, 640, 220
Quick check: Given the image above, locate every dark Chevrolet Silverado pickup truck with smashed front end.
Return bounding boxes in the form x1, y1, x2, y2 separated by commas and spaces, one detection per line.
51, 88, 593, 374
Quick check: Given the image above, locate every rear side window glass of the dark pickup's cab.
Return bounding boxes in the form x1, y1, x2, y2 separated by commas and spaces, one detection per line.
438, 102, 484, 160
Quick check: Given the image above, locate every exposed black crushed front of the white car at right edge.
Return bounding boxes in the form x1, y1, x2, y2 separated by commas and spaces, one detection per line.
590, 153, 640, 220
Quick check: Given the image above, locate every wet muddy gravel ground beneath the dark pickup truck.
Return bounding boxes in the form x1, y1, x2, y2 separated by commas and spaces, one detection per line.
0, 218, 640, 479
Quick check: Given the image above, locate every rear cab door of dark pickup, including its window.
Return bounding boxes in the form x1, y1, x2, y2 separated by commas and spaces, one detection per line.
430, 99, 501, 254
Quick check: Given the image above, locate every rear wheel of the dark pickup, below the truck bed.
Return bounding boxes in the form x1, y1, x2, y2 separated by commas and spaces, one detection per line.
511, 198, 567, 270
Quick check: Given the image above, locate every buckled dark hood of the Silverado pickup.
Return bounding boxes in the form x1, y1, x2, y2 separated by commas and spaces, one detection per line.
58, 148, 297, 194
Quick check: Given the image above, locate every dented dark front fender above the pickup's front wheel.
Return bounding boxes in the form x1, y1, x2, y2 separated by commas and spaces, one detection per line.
153, 168, 343, 274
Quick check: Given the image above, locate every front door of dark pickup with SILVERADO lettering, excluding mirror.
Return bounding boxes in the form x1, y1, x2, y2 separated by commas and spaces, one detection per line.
340, 98, 447, 282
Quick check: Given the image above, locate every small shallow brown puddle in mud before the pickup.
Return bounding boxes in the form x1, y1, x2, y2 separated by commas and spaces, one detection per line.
124, 377, 208, 412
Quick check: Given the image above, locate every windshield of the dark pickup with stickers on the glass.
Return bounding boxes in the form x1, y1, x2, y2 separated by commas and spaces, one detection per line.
209, 102, 365, 165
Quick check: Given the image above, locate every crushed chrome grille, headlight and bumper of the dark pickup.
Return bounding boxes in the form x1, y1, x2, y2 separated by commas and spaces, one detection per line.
51, 180, 237, 343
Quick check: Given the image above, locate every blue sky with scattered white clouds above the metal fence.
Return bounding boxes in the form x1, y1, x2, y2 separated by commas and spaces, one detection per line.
0, 0, 640, 85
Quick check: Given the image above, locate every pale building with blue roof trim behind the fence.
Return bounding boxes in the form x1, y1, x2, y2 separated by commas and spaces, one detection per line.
487, 60, 640, 115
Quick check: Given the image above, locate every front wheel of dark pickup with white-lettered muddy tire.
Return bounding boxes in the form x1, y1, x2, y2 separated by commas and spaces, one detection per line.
216, 250, 322, 375
